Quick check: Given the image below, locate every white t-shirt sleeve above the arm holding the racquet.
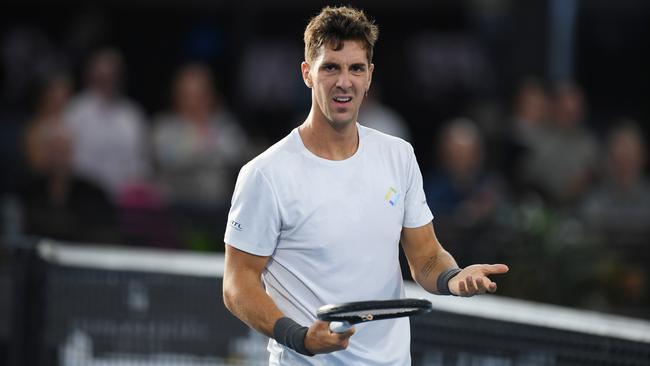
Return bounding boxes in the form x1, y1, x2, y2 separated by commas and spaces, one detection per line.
224, 165, 281, 256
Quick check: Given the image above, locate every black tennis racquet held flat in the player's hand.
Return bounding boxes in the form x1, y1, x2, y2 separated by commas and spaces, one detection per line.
316, 299, 431, 333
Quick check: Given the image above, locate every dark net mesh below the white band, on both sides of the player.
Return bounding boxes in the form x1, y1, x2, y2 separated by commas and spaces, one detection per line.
27, 242, 650, 366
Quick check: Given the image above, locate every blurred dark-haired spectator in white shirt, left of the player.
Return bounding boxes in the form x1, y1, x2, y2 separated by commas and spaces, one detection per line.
66, 48, 150, 199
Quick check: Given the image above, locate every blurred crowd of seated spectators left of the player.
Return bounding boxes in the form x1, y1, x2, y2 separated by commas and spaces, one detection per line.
2, 43, 254, 250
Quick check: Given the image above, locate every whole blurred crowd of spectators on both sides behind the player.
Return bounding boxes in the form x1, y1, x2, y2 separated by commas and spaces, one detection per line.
0, 41, 650, 317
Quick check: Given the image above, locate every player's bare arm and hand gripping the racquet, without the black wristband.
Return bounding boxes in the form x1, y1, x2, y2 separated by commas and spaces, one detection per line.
223, 244, 354, 354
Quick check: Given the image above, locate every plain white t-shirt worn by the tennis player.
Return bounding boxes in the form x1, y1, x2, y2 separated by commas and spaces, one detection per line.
225, 124, 433, 365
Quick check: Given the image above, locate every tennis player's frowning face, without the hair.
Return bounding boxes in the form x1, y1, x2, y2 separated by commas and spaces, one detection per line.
301, 41, 374, 128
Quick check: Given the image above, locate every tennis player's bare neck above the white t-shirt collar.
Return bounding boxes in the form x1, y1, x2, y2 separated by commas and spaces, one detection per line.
298, 111, 359, 160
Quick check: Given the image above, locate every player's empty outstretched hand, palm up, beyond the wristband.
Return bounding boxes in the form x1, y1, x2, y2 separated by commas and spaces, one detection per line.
449, 264, 508, 297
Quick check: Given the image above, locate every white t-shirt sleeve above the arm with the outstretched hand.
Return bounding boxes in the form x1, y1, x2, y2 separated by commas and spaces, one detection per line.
403, 145, 433, 228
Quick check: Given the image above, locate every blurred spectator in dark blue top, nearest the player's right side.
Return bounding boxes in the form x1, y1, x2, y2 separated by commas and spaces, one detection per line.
424, 118, 503, 225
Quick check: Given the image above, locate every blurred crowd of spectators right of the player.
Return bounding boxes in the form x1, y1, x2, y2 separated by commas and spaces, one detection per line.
424, 79, 650, 317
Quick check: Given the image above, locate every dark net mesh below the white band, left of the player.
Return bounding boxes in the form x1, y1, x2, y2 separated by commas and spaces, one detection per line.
34, 264, 253, 365
